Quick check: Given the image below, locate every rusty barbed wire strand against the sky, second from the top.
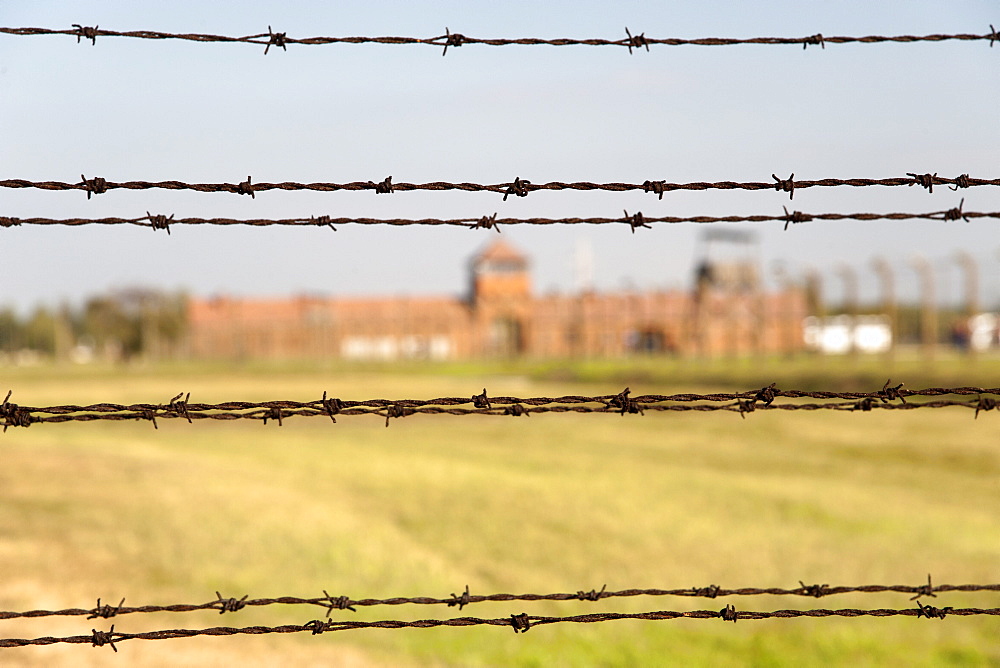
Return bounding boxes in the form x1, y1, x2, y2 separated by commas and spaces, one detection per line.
0, 172, 1000, 201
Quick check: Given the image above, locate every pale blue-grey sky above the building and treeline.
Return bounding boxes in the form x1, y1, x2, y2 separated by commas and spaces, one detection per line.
0, 0, 1000, 308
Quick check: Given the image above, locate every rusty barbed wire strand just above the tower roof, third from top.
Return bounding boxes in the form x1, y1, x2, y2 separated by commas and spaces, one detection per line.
0, 199, 988, 234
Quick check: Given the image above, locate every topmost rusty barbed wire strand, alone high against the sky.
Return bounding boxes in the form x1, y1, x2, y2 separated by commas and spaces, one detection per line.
0, 23, 1000, 56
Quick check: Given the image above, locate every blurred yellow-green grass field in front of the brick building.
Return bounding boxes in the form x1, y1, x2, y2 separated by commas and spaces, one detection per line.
0, 360, 1000, 666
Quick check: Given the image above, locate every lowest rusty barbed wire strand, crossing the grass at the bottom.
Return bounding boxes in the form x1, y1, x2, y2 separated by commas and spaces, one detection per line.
0, 601, 1000, 652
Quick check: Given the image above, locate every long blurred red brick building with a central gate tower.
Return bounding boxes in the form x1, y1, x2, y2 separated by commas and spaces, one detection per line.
188, 240, 807, 360
